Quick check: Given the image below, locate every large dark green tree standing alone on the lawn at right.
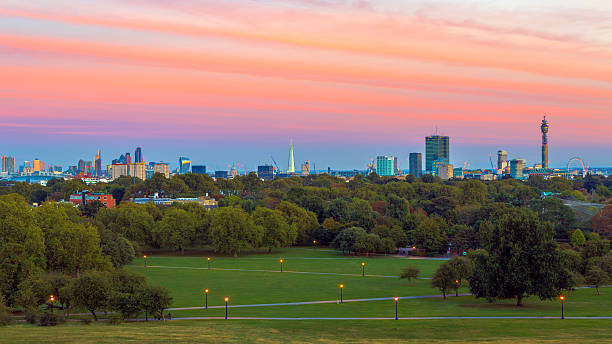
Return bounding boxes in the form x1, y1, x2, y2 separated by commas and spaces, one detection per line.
468, 208, 562, 306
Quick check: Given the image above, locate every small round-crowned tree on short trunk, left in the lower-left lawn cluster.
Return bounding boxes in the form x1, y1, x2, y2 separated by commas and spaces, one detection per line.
72, 271, 112, 321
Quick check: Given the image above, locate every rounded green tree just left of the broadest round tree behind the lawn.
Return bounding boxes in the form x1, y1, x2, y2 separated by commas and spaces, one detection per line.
153, 207, 197, 255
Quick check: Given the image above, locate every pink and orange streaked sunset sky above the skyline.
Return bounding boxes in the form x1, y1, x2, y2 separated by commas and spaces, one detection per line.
0, 0, 612, 170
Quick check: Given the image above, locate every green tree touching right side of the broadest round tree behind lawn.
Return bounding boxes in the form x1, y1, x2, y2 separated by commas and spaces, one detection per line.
253, 207, 297, 253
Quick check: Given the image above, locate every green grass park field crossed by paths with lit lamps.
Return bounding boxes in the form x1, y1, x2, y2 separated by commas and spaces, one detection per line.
0, 248, 612, 343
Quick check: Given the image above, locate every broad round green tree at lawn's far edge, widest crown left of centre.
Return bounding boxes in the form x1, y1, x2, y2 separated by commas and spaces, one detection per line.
210, 207, 264, 257
